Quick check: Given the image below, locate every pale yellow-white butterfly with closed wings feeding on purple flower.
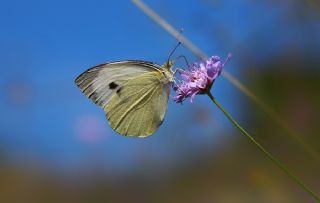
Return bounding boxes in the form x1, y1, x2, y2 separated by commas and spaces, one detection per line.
75, 60, 174, 137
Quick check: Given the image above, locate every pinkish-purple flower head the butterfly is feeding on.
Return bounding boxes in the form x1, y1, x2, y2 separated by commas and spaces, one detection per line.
173, 54, 231, 103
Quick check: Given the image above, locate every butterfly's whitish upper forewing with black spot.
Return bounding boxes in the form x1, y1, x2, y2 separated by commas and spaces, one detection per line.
75, 61, 161, 108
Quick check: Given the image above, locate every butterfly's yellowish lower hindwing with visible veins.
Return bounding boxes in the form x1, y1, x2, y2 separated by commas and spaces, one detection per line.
105, 72, 169, 137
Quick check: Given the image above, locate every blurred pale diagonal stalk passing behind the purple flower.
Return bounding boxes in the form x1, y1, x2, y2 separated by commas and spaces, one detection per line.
132, 0, 320, 163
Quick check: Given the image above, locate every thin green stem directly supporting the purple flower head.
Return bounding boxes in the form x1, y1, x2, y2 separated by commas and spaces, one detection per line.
207, 91, 320, 202
